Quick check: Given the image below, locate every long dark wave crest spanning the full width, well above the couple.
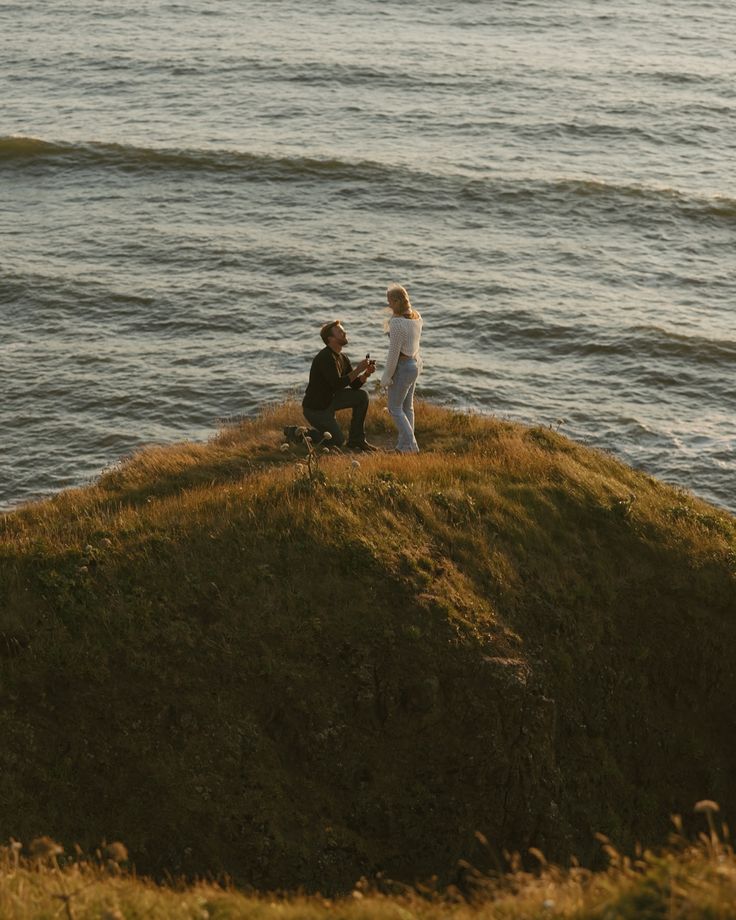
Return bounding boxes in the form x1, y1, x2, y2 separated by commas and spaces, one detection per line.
5, 136, 736, 222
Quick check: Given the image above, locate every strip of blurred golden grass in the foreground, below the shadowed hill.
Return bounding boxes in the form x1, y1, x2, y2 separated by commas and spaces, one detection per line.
0, 824, 736, 920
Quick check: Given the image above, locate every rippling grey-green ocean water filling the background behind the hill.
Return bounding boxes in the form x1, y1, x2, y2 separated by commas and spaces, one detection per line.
0, 0, 736, 511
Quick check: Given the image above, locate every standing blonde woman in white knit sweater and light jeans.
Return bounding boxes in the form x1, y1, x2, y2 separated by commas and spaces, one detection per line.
381, 284, 422, 454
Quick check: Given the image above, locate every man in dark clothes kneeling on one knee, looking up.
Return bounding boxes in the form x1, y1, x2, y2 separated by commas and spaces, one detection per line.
294, 320, 376, 451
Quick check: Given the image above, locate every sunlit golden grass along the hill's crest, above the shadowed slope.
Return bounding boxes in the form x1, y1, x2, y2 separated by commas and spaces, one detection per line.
0, 401, 735, 555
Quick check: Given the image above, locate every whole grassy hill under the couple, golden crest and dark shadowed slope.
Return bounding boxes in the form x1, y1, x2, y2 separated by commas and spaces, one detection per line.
0, 404, 736, 891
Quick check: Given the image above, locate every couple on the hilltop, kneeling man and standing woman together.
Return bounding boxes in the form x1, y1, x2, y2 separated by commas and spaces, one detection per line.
284, 284, 422, 453
